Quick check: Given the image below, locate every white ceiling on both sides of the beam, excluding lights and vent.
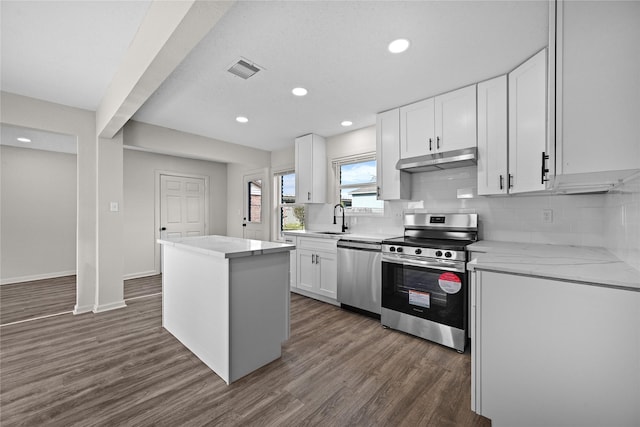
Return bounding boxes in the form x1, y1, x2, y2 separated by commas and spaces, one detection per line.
1, 0, 548, 154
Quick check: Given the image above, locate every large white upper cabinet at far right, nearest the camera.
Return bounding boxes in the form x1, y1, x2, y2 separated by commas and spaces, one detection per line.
550, 1, 640, 190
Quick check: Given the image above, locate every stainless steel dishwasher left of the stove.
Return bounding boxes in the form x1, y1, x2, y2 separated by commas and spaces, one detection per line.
338, 239, 382, 318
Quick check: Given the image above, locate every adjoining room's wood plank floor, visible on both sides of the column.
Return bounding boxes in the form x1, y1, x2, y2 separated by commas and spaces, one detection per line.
0, 275, 162, 325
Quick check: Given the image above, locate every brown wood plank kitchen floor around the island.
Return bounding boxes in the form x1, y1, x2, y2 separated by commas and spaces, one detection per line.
0, 277, 490, 427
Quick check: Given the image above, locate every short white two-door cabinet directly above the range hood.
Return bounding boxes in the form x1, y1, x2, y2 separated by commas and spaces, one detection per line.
400, 85, 476, 159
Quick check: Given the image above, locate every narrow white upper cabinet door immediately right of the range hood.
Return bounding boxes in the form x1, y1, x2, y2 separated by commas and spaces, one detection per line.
478, 75, 508, 195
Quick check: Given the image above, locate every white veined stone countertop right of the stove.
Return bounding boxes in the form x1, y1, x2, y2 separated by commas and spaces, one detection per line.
467, 240, 640, 292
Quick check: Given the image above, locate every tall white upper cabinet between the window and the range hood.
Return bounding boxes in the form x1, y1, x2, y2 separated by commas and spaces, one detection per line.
376, 108, 411, 200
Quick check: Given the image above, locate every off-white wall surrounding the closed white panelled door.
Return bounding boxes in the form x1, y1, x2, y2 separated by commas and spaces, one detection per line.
123, 150, 227, 278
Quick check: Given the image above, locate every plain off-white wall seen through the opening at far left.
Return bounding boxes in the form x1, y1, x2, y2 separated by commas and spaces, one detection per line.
0, 145, 77, 283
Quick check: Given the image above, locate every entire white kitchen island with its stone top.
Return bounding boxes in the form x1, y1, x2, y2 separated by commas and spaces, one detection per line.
158, 236, 295, 384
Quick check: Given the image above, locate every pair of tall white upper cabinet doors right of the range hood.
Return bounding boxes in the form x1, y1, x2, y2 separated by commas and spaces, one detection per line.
478, 49, 552, 195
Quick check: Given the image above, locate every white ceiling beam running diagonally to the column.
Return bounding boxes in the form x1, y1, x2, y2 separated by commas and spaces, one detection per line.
96, 0, 234, 138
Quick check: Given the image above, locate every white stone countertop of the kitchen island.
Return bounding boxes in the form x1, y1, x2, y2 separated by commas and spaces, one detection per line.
158, 236, 295, 258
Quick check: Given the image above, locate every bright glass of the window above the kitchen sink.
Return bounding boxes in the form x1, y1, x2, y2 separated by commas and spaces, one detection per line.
340, 160, 384, 211
